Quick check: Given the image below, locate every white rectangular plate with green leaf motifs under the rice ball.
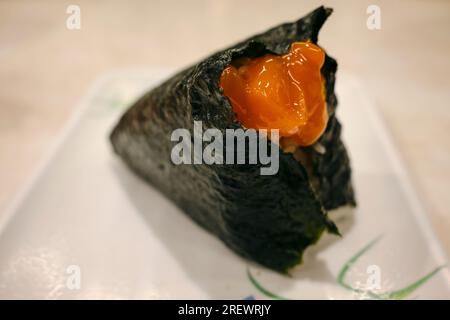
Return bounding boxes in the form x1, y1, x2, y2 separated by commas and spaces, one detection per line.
0, 69, 450, 299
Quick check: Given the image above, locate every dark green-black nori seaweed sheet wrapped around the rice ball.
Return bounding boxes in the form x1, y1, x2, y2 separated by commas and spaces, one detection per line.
111, 7, 355, 272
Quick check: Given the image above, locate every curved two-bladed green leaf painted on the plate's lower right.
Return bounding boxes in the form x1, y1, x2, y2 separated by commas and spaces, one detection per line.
337, 235, 447, 300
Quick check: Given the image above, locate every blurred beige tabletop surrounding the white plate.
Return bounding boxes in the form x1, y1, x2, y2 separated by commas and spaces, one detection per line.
0, 0, 450, 255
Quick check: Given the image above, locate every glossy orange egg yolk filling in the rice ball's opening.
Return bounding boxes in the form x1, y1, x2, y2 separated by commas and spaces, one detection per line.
219, 42, 328, 149
